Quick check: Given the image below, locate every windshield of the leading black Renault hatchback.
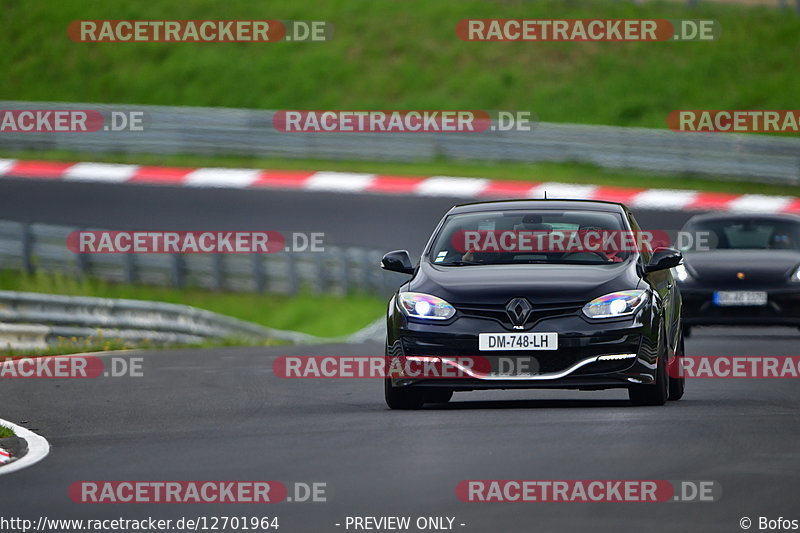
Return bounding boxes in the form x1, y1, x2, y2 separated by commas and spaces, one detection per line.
428, 209, 636, 266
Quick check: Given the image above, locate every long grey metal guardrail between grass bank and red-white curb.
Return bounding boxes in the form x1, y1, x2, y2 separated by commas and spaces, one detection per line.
0, 101, 800, 185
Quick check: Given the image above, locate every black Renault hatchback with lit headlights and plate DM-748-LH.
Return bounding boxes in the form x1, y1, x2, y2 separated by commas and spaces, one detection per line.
381, 200, 684, 409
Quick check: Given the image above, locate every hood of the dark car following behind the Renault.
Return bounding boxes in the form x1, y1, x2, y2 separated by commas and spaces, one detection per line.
684, 250, 800, 283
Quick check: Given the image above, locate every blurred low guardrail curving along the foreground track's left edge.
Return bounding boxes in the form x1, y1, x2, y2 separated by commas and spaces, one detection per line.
0, 291, 383, 349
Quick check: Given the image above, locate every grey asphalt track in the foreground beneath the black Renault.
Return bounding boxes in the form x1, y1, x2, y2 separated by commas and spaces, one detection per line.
0, 328, 800, 533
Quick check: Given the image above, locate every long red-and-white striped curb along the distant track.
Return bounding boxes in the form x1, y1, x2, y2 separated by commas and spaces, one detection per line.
0, 159, 800, 213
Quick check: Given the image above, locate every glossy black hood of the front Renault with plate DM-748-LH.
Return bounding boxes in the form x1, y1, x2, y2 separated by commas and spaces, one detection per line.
408, 261, 639, 305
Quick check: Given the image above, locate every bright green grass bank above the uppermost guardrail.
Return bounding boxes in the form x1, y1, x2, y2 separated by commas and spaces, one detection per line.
6, 0, 800, 128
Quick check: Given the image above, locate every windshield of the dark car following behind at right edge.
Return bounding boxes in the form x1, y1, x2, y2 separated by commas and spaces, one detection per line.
679, 217, 800, 252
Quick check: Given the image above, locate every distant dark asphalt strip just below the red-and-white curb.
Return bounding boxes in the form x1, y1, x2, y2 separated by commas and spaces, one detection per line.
0, 178, 693, 253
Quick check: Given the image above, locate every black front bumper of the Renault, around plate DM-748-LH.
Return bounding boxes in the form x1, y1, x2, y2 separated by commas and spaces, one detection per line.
387, 312, 658, 391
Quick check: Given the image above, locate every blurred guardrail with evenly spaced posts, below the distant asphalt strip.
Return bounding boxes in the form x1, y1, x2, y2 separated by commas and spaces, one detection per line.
0, 220, 405, 296
